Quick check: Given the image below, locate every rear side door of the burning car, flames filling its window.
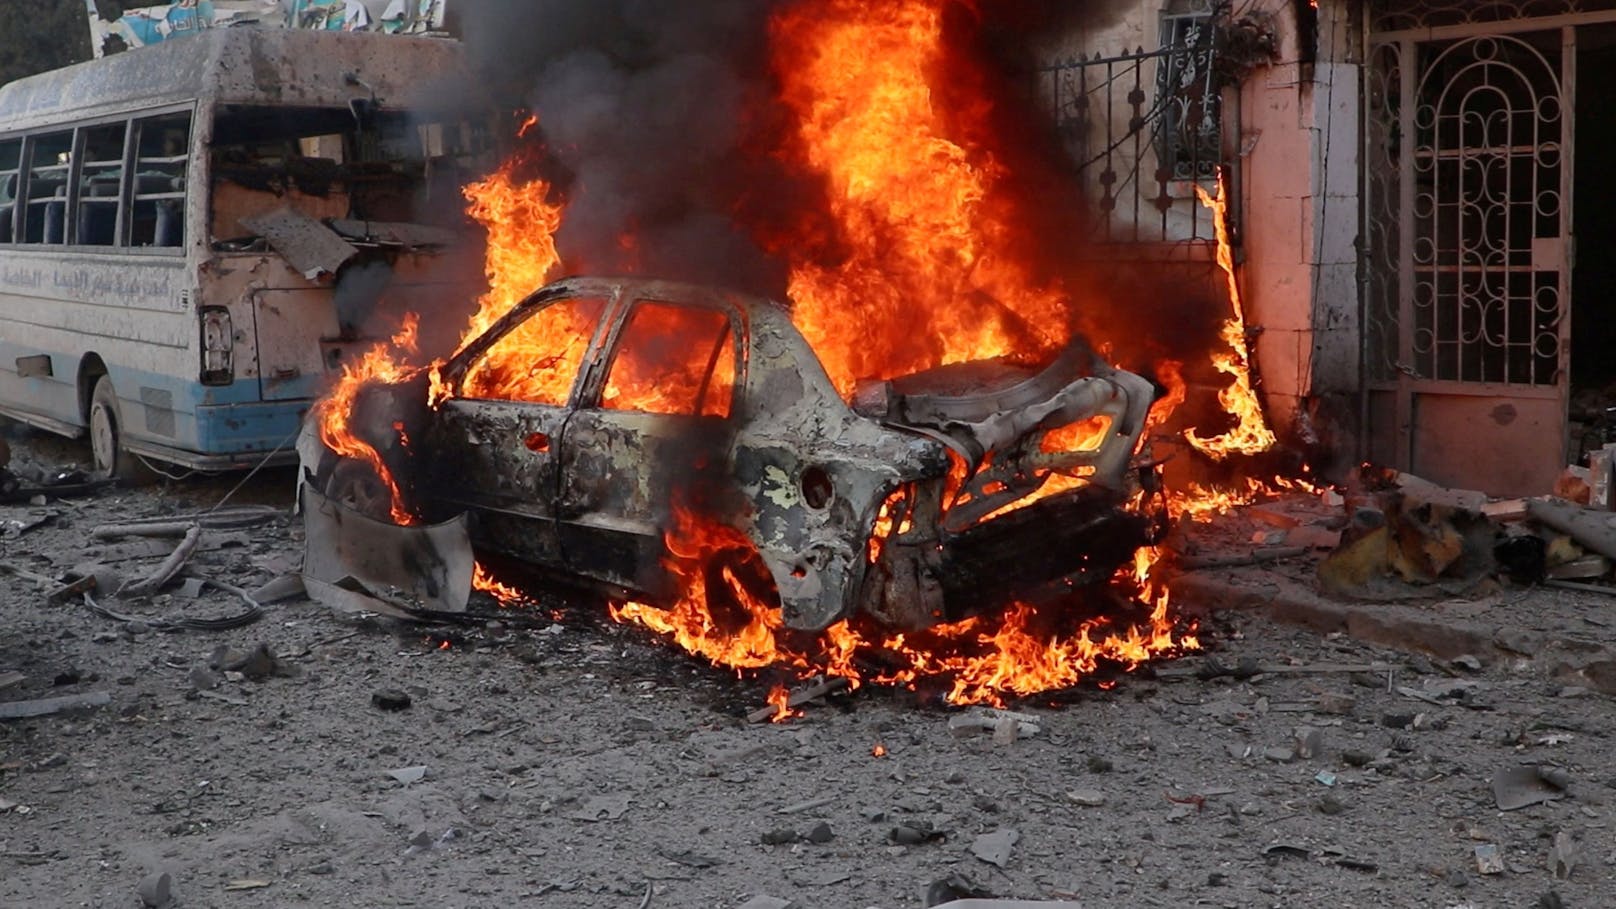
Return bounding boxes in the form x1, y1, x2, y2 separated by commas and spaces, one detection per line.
558, 299, 743, 595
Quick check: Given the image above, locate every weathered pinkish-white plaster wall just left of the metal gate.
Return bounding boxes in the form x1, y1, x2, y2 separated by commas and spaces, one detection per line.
1041, 0, 1361, 459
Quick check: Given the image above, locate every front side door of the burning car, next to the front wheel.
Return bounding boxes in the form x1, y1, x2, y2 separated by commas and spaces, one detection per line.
425, 294, 611, 564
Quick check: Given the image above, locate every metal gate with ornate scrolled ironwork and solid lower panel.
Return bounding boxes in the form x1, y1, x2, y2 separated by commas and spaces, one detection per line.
1364, 23, 1576, 495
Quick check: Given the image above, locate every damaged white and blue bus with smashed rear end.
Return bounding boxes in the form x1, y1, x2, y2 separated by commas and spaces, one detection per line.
0, 27, 493, 476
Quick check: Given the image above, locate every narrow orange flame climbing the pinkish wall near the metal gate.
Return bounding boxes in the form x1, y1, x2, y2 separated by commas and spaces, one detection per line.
1185, 171, 1277, 459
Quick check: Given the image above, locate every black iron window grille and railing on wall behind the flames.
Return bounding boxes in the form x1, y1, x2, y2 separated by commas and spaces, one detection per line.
1037, 11, 1223, 244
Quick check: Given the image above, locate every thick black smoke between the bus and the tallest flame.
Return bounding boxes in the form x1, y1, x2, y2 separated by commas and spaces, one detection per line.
461, 0, 813, 296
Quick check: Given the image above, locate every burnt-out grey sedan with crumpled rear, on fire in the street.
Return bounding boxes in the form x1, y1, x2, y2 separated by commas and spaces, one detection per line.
299, 278, 1159, 631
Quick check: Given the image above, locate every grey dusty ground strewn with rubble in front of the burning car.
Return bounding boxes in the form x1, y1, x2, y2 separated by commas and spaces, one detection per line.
0, 423, 1616, 909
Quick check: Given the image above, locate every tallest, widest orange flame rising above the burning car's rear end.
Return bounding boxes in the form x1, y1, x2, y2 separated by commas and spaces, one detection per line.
771, 0, 1068, 393
